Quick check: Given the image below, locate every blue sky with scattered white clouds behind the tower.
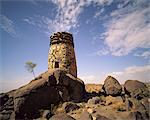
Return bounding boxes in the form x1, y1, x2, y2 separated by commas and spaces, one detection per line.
0, 0, 150, 92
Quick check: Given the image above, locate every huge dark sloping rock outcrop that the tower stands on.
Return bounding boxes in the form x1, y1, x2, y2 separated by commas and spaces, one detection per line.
0, 69, 85, 120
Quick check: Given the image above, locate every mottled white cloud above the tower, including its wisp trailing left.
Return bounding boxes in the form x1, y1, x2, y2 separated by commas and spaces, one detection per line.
23, 0, 113, 33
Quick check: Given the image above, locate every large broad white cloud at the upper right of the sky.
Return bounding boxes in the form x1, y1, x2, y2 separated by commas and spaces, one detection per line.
99, 0, 150, 56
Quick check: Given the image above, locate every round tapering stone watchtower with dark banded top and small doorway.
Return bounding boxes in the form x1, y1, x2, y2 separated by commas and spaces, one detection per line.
48, 32, 77, 77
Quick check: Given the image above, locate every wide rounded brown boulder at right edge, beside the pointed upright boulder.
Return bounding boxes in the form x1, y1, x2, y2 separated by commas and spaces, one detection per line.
124, 80, 149, 100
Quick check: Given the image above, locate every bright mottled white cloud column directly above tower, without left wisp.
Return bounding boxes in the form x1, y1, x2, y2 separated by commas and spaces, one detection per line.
49, 0, 112, 31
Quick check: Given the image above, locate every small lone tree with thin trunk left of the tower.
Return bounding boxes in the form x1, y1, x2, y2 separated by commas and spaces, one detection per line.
25, 61, 36, 78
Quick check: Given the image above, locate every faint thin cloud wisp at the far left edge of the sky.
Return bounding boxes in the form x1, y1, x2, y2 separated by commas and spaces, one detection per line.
0, 15, 16, 37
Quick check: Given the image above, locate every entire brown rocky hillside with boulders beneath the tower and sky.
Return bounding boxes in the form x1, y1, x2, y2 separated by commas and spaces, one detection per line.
0, 69, 150, 120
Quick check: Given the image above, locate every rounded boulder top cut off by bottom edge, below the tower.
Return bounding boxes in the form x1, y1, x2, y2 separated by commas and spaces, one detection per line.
49, 113, 75, 120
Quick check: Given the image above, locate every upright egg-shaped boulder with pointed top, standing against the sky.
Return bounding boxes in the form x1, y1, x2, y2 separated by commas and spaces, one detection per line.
102, 76, 122, 96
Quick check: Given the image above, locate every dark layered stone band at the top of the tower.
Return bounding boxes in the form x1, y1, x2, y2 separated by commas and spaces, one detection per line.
50, 32, 74, 47
